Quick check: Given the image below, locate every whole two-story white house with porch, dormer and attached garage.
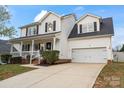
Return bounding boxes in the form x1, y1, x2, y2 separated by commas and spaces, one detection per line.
10, 12, 114, 63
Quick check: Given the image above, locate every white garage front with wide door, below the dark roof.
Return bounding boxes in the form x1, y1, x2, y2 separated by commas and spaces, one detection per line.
68, 37, 113, 63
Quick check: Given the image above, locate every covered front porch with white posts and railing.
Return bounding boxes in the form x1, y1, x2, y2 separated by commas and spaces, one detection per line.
10, 32, 60, 64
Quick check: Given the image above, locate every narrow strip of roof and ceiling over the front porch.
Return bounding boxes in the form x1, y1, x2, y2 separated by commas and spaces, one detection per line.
9, 32, 60, 42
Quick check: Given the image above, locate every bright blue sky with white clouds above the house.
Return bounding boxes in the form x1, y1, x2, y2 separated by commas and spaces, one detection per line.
2, 5, 124, 47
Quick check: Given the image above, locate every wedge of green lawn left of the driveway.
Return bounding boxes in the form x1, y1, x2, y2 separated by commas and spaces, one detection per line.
0, 64, 35, 80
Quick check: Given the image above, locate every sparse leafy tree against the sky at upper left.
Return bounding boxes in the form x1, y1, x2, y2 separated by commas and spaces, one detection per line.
0, 5, 16, 38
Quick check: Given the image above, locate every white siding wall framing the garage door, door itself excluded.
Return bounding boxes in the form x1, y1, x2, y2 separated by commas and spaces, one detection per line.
68, 37, 113, 60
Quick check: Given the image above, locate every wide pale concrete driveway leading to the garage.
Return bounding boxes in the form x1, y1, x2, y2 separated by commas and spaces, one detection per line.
0, 63, 105, 88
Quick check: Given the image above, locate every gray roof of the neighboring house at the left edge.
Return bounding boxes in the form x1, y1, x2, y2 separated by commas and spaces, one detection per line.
0, 40, 11, 55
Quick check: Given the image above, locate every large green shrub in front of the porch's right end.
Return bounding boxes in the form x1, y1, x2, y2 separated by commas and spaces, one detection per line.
42, 50, 59, 64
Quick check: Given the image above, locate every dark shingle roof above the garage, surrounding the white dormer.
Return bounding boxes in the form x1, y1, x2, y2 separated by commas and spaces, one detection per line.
68, 17, 114, 38
